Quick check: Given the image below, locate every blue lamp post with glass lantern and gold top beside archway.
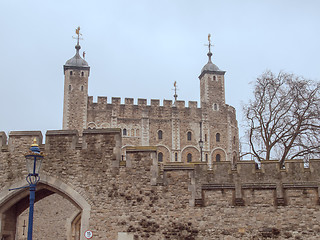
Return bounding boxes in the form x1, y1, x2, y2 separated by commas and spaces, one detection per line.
25, 139, 44, 240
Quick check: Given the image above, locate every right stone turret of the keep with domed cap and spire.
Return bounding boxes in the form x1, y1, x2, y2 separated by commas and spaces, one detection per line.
199, 34, 225, 111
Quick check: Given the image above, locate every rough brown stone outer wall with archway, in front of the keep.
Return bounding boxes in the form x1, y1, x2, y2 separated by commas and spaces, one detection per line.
0, 129, 320, 240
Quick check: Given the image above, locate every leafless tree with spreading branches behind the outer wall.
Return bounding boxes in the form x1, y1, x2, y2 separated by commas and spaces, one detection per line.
243, 71, 320, 165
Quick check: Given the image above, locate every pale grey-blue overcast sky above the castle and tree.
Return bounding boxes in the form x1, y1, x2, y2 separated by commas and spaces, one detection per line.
0, 0, 320, 142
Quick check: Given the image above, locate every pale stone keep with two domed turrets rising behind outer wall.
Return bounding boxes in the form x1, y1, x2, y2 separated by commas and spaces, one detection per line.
63, 33, 239, 164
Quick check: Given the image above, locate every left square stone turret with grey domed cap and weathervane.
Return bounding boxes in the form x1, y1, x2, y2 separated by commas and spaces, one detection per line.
62, 27, 90, 134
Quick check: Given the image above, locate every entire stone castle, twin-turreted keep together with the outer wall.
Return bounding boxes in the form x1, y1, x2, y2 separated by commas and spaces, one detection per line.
0, 31, 320, 240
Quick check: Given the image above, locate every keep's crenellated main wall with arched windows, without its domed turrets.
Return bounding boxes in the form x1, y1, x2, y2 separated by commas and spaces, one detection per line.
87, 97, 239, 162
